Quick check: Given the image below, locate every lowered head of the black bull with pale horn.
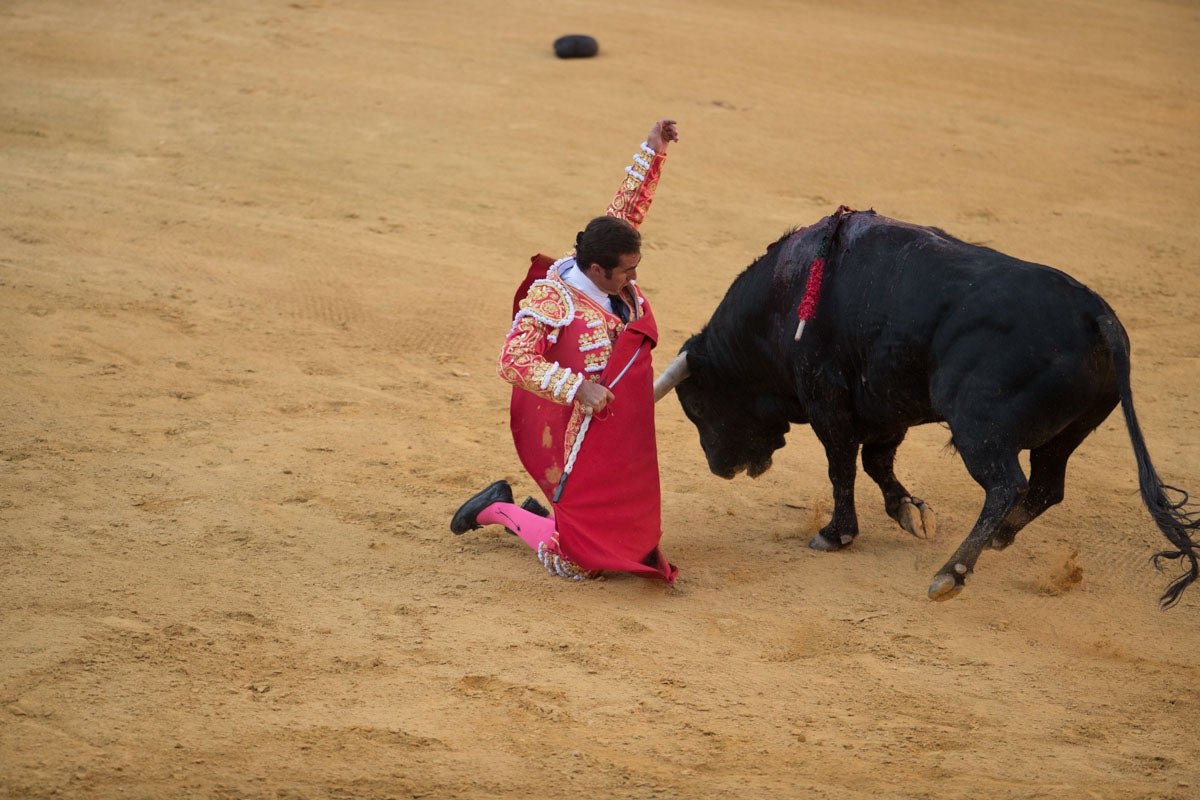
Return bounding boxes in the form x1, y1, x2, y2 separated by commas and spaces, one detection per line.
654, 333, 791, 479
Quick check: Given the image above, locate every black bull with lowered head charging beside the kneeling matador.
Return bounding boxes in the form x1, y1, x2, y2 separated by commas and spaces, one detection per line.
655, 211, 1200, 607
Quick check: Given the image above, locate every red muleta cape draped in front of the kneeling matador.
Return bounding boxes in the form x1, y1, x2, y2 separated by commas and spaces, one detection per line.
509, 255, 678, 583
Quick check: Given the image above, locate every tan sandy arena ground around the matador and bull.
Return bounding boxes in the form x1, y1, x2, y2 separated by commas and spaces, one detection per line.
0, 0, 1200, 800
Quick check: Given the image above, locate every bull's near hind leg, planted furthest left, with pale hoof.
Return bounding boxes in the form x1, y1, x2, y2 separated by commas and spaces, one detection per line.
929, 450, 1028, 600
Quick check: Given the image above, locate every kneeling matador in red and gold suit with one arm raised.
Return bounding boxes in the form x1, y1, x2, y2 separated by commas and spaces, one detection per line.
450, 120, 679, 583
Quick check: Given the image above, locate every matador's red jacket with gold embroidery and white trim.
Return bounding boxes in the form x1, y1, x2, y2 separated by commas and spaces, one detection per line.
497, 143, 666, 405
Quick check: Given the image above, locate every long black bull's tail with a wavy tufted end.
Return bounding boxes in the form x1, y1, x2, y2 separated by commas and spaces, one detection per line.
1098, 314, 1200, 608
